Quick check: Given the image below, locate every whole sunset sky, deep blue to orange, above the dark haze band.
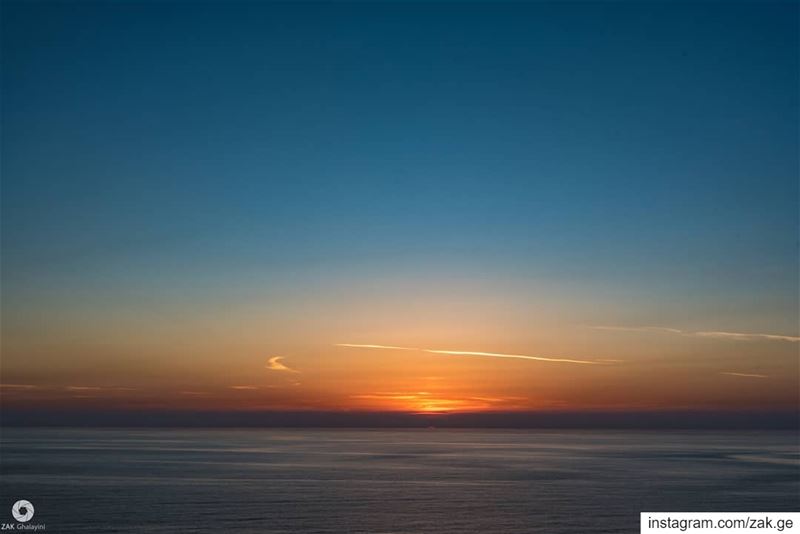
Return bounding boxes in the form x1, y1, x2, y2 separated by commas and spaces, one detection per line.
0, 1, 800, 414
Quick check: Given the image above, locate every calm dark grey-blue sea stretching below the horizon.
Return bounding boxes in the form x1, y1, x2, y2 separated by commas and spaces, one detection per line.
0, 429, 800, 534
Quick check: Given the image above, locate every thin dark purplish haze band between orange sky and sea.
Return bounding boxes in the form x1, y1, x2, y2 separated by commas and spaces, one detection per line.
0, 407, 800, 431
